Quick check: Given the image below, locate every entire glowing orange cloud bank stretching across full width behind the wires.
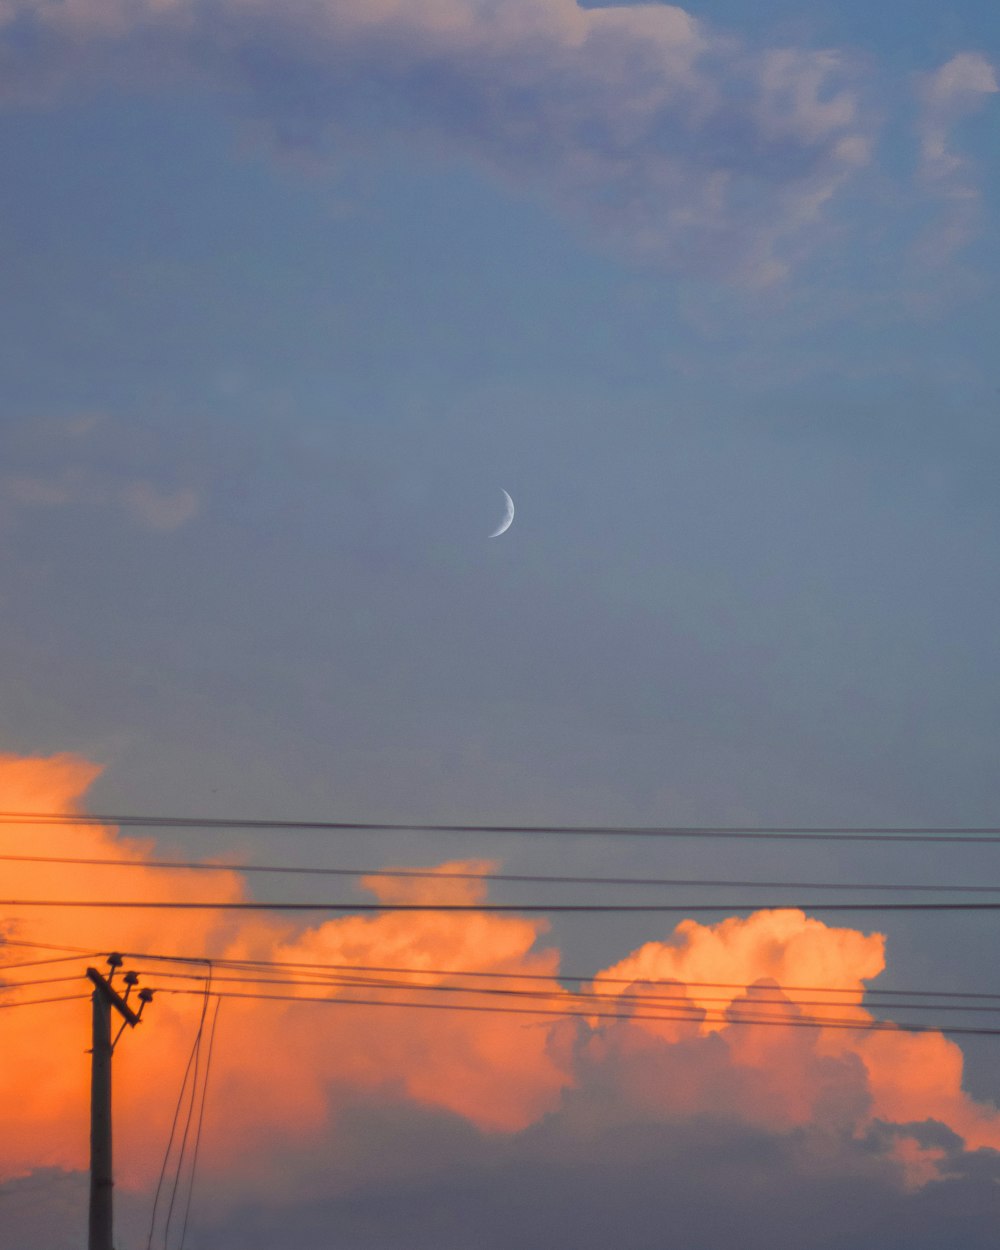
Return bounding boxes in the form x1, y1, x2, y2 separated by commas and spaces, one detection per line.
0, 756, 1000, 1230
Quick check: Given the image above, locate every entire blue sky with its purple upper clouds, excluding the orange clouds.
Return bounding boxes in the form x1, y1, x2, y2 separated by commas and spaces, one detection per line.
0, 0, 1000, 1240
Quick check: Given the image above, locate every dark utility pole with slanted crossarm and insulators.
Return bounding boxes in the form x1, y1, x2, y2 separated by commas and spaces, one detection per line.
86, 954, 153, 1250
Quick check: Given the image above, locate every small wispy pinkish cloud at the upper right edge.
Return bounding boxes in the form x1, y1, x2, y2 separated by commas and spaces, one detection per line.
918, 53, 999, 260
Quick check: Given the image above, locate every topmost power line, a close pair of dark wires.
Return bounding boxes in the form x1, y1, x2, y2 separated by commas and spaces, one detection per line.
0, 811, 1000, 845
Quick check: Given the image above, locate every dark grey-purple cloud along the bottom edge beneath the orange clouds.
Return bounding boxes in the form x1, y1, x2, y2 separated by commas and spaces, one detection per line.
200, 1091, 1000, 1250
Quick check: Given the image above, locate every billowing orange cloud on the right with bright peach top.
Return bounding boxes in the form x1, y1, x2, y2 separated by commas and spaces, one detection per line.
585, 909, 1000, 1179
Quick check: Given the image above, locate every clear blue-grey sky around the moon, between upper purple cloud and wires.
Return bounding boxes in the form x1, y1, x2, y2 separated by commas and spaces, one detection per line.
7, 36, 998, 821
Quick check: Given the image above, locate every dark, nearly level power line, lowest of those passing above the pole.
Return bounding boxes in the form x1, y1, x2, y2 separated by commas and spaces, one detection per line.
0, 899, 1000, 915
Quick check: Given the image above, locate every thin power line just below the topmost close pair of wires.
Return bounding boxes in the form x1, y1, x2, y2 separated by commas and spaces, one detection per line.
0, 855, 1000, 894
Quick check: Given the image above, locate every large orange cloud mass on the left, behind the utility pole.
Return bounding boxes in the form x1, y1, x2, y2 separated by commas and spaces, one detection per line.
0, 756, 568, 1185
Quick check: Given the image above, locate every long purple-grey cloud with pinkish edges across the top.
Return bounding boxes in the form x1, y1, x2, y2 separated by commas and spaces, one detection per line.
0, 0, 875, 283
